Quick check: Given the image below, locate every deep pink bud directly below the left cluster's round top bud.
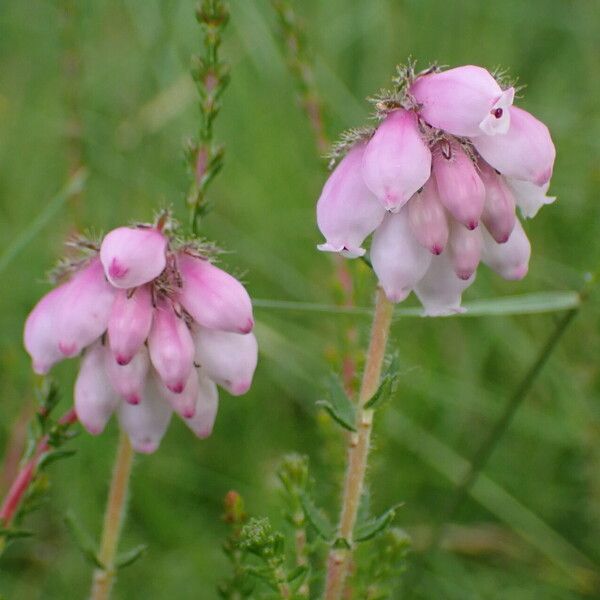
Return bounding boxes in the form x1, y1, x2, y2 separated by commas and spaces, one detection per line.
108, 285, 154, 365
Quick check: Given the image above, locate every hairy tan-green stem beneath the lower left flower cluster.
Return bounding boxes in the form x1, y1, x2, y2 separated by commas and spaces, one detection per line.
90, 432, 133, 600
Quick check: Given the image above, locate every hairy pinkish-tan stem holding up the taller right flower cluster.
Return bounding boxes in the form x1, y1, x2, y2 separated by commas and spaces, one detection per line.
325, 289, 394, 600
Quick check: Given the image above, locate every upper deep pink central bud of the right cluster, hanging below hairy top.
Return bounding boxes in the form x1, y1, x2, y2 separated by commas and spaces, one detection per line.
433, 142, 485, 229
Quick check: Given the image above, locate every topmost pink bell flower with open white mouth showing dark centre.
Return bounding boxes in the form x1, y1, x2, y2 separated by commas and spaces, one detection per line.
410, 65, 515, 137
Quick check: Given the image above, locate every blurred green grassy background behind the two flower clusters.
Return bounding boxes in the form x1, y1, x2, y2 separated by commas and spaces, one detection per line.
0, 0, 600, 600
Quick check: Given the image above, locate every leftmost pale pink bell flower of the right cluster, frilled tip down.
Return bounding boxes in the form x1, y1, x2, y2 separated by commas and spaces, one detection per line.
317, 142, 385, 258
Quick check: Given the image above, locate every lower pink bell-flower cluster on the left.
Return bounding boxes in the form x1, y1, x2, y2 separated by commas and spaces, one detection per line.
24, 226, 258, 453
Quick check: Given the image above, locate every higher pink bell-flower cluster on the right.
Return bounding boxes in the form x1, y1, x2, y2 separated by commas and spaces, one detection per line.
317, 66, 555, 315
